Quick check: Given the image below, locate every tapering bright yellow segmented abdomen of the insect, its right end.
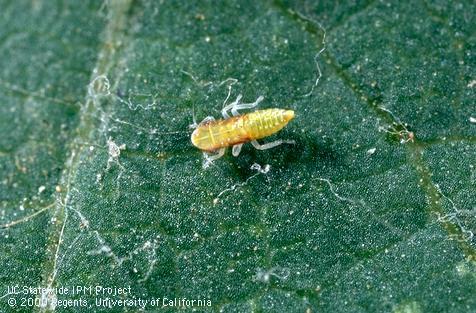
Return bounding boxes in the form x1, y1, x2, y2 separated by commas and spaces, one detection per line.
244, 109, 294, 140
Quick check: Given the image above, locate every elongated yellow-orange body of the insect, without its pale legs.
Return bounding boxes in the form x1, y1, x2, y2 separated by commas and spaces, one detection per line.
191, 109, 294, 151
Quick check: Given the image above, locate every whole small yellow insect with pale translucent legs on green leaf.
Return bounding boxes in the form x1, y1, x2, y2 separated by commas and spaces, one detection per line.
191, 95, 295, 165
